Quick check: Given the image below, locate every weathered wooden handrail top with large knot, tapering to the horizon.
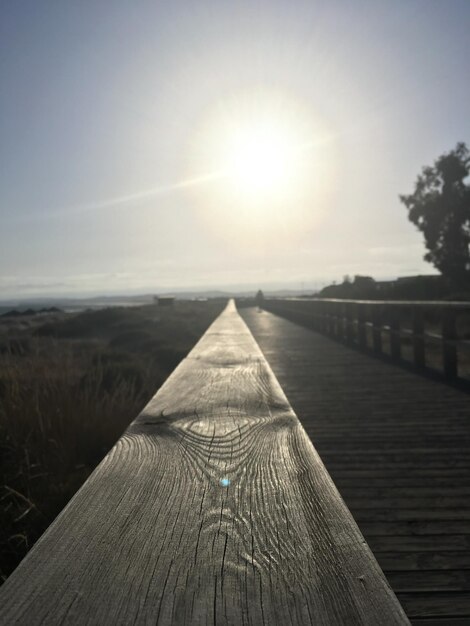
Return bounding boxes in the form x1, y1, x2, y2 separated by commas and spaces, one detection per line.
0, 303, 408, 626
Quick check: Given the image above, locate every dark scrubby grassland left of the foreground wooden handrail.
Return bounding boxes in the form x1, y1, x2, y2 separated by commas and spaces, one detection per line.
0, 301, 224, 580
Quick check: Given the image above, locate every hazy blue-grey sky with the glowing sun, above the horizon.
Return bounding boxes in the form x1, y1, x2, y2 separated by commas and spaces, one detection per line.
0, 0, 470, 299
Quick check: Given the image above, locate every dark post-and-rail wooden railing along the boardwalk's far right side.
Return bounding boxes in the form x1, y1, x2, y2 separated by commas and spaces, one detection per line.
262, 298, 470, 380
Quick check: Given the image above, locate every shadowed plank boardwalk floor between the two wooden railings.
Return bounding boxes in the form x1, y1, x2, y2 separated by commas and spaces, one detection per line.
240, 308, 470, 626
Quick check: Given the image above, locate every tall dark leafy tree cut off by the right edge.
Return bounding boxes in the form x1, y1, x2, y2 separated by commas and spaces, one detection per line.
400, 143, 470, 286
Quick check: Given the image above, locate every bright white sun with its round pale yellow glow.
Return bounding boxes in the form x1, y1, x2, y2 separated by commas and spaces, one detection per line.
187, 90, 334, 245
